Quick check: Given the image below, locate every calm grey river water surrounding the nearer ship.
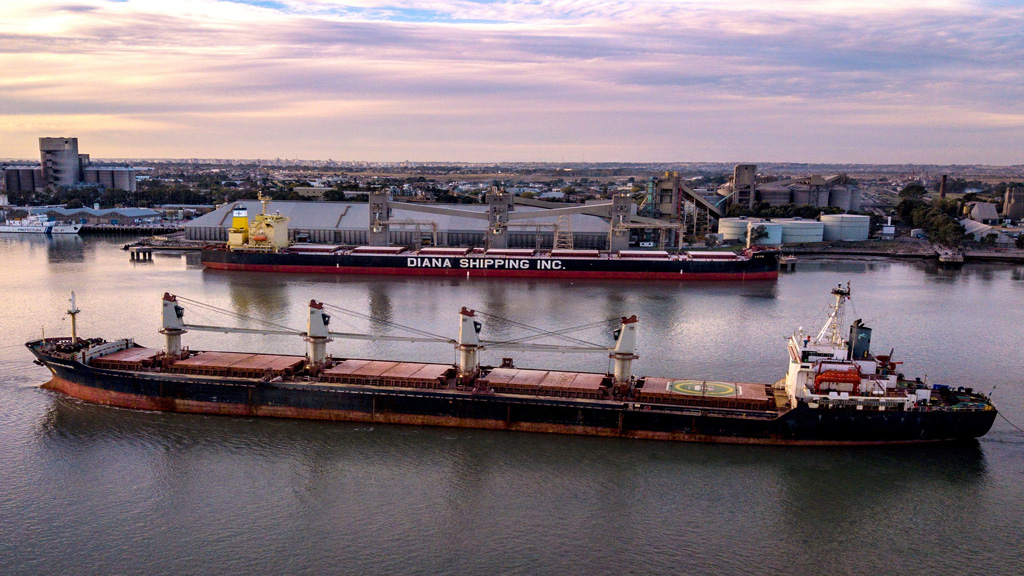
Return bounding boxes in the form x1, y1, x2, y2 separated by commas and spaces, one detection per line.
0, 235, 1024, 575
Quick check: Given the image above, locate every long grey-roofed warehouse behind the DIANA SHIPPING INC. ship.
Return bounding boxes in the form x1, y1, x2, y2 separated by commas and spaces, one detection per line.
185, 200, 609, 249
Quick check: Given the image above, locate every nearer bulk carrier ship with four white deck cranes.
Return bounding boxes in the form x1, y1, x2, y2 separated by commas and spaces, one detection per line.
26, 285, 997, 445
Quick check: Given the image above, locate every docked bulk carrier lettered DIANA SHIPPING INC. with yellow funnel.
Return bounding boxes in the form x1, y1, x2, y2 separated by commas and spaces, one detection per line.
201, 197, 779, 281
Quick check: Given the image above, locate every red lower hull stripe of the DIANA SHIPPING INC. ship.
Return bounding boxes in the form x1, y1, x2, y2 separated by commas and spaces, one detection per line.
203, 261, 778, 280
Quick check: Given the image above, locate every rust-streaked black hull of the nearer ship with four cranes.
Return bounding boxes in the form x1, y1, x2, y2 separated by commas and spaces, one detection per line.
28, 342, 996, 445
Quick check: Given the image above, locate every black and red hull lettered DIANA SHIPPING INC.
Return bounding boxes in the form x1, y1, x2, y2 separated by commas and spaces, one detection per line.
201, 247, 779, 281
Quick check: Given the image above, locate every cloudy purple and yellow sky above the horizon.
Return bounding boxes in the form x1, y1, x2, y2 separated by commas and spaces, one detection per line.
0, 0, 1024, 165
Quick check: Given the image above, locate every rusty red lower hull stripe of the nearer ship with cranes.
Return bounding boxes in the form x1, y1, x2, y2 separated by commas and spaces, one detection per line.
43, 377, 940, 446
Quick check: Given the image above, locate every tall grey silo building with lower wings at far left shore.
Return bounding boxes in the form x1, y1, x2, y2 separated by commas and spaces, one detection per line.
3, 137, 136, 194
